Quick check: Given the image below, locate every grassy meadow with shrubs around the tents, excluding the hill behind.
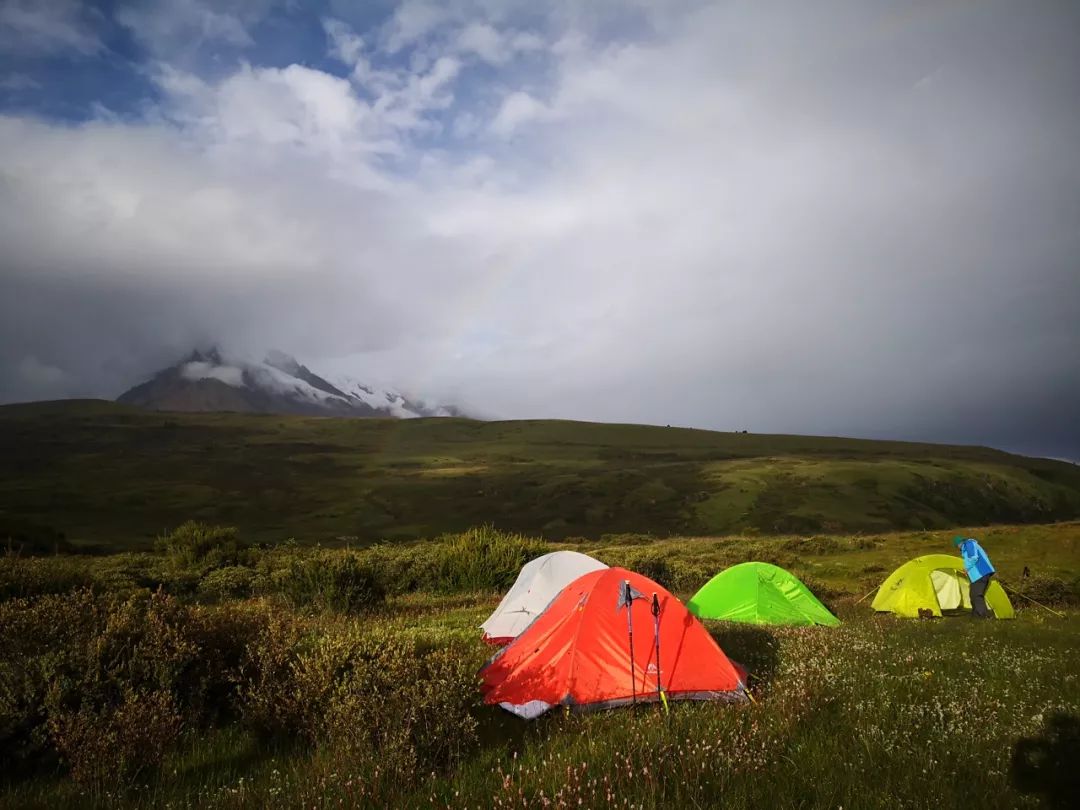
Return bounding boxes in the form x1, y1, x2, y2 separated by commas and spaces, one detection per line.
0, 522, 1080, 808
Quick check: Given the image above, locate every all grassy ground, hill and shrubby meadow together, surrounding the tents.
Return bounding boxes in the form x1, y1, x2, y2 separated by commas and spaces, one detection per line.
0, 402, 1080, 808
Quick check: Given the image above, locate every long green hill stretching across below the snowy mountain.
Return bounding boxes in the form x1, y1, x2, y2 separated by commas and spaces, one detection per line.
0, 401, 1080, 545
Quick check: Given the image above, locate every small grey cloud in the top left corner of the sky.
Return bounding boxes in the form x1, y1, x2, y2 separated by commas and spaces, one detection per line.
0, 0, 102, 56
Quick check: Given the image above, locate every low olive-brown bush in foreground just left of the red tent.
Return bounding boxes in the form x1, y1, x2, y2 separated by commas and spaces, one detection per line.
242, 619, 477, 784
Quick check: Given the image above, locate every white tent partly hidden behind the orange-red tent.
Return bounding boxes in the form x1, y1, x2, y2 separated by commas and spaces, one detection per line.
480, 551, 607, 644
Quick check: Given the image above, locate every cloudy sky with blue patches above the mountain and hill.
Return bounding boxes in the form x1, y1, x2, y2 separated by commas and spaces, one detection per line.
0, 0, 1080, 459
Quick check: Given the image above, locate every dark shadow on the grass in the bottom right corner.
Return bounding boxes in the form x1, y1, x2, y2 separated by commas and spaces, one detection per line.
1011, 712, 1080, 810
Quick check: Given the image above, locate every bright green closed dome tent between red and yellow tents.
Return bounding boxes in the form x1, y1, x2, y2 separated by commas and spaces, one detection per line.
686, 563, 840, 627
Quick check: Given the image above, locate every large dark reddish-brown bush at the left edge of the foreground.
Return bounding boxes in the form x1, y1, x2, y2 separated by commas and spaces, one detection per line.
0, 590, 267, 786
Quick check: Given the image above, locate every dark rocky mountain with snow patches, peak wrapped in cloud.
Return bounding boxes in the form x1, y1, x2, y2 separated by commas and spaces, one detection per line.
118, 349, 457, 419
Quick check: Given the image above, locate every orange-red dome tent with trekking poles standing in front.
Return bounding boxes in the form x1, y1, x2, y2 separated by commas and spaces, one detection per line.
480, 568, 745, 718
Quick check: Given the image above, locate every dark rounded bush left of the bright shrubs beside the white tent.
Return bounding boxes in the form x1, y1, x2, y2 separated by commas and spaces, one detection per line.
272, 552, 387, 613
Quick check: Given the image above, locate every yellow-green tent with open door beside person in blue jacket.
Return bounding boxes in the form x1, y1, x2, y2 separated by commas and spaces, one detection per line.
870, 554, 1015, 619
